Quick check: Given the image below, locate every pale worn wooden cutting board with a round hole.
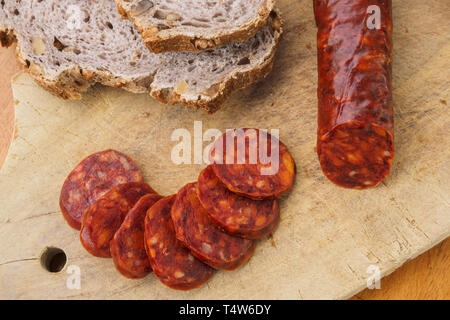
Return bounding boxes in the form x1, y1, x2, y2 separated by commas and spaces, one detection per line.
0, 0, 450, 299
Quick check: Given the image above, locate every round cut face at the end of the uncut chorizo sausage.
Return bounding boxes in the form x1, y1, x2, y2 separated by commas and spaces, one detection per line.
317, 122, 394, 189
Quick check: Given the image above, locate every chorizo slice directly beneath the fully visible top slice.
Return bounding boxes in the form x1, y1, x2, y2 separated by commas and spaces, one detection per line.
197, 166, 280, 239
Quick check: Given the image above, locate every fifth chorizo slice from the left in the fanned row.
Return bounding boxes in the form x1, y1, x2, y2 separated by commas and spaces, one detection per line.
171, 183, 255, 270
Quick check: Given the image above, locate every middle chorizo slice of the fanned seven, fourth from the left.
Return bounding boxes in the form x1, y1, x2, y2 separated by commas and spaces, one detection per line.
145, 195, 214, 290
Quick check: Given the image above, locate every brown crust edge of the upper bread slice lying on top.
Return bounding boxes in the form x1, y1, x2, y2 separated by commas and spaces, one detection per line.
116, 0, 275, 53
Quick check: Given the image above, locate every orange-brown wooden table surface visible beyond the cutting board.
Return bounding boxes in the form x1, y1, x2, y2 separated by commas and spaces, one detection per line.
0, 0, 450, 299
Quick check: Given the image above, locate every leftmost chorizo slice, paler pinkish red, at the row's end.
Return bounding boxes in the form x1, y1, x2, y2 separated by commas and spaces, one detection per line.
59, 150, 142, 230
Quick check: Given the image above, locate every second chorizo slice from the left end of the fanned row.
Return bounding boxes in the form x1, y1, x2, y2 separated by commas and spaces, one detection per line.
80, 182, 156, 258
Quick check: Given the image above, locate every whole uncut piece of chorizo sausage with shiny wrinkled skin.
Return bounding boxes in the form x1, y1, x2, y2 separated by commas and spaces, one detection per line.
314, 0, 394, 189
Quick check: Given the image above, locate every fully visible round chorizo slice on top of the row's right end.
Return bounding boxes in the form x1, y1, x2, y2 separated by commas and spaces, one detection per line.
210, 129, 295, 199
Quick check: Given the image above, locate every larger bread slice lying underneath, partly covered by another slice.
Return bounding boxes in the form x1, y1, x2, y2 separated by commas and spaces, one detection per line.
0, 0, 282, 113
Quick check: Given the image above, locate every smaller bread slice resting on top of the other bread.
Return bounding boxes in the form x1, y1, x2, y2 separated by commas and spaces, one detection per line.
116, 0, 274, 53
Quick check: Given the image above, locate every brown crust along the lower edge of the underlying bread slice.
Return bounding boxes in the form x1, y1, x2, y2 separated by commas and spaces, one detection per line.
0, 10, 283, 114
